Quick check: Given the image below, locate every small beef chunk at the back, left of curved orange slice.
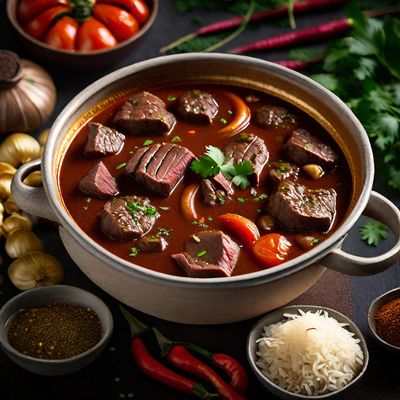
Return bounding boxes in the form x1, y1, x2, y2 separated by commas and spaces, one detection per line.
176, 90, 218, 124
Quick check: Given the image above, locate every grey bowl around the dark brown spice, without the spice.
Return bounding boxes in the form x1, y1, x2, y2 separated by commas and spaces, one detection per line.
0, 285, 114, 375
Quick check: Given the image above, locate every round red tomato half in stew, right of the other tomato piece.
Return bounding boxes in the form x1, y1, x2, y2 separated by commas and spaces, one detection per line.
253, 233, 292, 267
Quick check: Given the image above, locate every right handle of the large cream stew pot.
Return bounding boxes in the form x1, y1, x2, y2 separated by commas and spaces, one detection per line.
321, 191, 400, 276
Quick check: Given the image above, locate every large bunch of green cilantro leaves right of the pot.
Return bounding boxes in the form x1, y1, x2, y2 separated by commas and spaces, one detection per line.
312, 4, 400, 189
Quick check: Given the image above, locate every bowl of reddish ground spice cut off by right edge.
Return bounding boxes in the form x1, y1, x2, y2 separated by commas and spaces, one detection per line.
368, 288, 400, 352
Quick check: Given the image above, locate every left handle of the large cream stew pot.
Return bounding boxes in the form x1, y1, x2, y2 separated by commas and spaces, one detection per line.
11, 160, 58, 223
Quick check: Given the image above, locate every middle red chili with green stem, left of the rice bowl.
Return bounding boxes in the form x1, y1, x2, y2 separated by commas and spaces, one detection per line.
153, 328, 247, 400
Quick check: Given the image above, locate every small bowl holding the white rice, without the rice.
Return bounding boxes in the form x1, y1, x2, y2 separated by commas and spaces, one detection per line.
247, 305, 369, 400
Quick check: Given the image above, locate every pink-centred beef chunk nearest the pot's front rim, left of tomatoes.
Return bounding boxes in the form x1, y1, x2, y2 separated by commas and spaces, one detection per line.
172, 231, 240, 278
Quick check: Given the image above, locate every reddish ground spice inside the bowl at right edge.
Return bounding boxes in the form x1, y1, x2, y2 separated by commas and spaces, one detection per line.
374, 298, 400, 346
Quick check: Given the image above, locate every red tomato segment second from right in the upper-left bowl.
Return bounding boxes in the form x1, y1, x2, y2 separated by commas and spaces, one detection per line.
93, 4, 139, 42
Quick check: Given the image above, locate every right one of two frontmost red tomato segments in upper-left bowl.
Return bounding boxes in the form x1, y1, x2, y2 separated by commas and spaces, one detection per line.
75, 17, 117, 51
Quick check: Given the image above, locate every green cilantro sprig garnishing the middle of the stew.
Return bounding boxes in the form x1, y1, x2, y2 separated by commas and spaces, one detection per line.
190, 146, 254, 189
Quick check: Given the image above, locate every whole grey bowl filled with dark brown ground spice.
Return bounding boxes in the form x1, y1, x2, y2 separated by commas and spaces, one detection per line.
0, 285, 114, 375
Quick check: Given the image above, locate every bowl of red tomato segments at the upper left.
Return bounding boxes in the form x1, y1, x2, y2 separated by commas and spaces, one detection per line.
7, 0, 158, 68
